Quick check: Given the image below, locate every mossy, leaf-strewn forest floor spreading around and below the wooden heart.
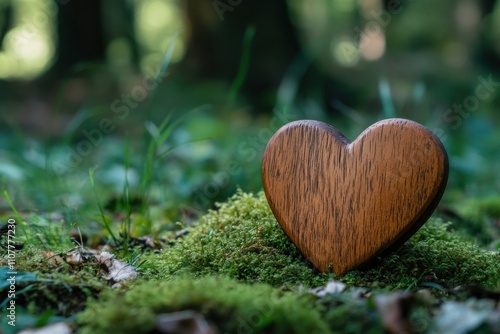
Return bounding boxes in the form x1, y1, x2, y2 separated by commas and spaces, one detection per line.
0, 160, 500, 334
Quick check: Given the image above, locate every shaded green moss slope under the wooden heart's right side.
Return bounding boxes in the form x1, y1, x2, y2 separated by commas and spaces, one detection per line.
343, 219, 500, 288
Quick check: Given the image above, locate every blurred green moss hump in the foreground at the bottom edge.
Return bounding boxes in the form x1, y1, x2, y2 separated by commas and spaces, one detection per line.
78, 277, 328, 334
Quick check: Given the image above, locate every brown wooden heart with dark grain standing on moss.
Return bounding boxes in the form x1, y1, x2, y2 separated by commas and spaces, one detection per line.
262, 119, 448, 275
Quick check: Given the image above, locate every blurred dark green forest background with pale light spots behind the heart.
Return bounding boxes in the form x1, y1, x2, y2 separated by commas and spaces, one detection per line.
0, 0, 500, 223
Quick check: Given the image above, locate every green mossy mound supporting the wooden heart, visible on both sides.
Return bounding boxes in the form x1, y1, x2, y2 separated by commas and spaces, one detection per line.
145, 192, 500, 288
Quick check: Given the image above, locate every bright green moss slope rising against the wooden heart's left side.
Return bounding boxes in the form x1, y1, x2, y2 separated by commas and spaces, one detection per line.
143, 192, 333, 286
